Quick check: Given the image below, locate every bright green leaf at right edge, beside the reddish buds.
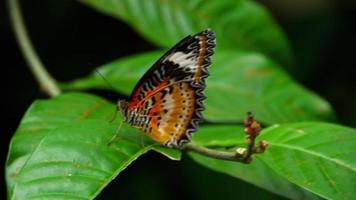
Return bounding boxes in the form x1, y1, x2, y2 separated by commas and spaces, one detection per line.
261, 123, 356, 199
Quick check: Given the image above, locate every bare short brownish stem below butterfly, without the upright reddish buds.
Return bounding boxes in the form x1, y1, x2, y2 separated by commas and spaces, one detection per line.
182, 143, 246, 163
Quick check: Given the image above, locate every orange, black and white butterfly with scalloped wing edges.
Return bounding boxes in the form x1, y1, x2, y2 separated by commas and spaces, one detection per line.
117, 29, 215, 147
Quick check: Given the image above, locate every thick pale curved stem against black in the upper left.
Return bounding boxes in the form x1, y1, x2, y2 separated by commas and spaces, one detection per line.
7, 0, 61, 96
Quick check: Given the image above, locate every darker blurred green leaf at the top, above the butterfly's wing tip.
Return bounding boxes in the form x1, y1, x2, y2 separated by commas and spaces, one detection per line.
81, 0, 292, 67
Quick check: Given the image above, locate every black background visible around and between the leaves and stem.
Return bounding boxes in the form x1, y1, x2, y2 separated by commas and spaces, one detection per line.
0, 0, 356, 199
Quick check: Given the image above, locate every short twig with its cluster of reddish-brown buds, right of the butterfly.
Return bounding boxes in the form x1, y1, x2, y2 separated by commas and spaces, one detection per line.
181, 112, 268, 164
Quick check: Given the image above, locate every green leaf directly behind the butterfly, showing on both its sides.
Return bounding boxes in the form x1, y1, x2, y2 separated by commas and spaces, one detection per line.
62, 51, 333, 124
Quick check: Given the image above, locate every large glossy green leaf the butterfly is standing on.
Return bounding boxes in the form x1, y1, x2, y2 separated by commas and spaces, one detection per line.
6, 93, 180, 199
